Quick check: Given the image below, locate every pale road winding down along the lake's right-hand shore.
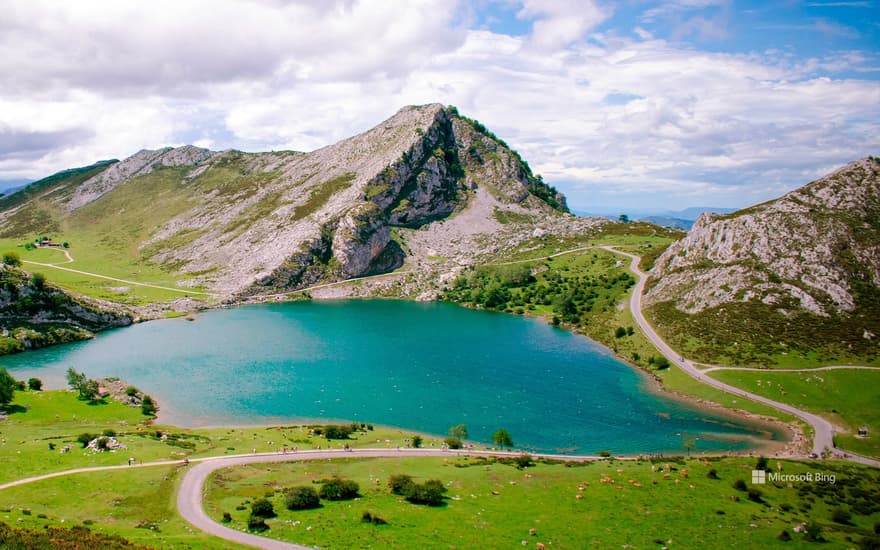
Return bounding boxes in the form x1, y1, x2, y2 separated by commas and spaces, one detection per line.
601, 246, 880, 466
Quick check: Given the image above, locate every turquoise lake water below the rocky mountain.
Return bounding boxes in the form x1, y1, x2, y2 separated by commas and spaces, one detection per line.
0, 300, 783, 454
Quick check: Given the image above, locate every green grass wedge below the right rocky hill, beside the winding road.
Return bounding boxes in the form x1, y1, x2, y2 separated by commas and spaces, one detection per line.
710, 370, 880, 457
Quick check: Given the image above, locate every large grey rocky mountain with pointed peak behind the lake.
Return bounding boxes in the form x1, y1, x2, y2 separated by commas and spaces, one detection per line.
0, 104, 567, 299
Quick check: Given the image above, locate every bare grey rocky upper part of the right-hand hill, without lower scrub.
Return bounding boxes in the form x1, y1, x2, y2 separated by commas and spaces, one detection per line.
646, 158, 880, 316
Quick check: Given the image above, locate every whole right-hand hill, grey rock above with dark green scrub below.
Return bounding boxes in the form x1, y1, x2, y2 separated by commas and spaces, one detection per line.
645, 158, 880, 364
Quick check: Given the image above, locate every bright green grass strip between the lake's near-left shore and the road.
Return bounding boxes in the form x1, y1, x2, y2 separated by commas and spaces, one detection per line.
0, 390, 440, 483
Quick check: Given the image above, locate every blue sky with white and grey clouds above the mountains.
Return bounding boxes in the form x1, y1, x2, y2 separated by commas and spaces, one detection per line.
0, 0, 880, 212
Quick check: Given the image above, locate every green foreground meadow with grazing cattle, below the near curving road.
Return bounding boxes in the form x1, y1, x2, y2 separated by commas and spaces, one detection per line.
206, 456, 880, 548
